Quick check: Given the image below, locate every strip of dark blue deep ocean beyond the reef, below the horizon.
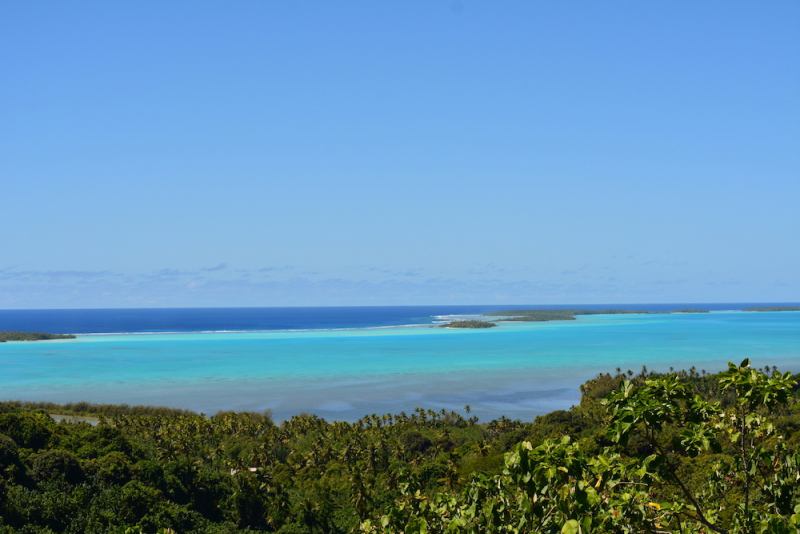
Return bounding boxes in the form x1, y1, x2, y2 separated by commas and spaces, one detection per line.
0, 303, 797, 334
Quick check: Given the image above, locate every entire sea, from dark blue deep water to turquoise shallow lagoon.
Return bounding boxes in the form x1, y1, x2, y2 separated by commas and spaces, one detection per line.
0, 303, 800, 421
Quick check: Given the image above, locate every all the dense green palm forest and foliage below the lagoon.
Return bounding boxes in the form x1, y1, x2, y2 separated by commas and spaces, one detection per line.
0, 361, 800, 534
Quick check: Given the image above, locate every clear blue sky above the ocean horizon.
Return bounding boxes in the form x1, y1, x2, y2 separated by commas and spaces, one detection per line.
0, 0, 800, 309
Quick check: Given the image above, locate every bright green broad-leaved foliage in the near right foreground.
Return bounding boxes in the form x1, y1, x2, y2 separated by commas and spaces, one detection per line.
368, 361, 800, 534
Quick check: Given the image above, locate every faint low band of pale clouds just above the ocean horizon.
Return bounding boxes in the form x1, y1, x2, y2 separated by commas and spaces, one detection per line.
0, 263, 798, 309
